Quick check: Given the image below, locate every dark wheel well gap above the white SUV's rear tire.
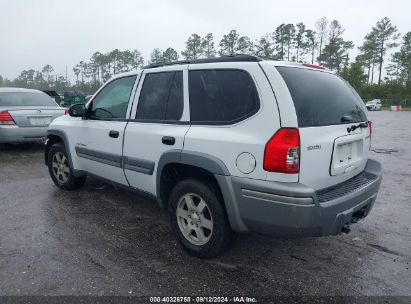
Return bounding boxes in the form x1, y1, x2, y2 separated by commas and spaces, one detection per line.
159, 163, 225, 208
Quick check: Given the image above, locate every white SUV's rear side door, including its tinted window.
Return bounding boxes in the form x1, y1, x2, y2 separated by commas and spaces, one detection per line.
123, 65, 190, 195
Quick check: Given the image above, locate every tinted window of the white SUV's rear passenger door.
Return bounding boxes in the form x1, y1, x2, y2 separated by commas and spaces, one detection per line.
136, 71, 184, 120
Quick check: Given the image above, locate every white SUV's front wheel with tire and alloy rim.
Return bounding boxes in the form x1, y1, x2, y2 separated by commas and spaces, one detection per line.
47, 143, 87, 190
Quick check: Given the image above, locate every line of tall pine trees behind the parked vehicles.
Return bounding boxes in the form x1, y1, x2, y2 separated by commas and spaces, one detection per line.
0, 17, 411, 99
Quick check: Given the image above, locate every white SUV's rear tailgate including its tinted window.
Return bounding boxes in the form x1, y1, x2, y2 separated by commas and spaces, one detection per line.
277, 66, 370, 190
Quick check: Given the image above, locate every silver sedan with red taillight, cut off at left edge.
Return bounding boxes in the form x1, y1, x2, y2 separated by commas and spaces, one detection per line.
0, 88, 66, 143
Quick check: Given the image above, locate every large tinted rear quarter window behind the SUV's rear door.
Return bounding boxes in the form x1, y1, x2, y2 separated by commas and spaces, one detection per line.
189, 70, 260, 124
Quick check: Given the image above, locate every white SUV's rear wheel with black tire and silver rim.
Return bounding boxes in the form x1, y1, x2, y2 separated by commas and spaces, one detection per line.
169, 179, 234, 259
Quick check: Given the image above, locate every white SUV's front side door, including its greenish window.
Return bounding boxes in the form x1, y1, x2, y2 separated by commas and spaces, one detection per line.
75, 75, 137, 185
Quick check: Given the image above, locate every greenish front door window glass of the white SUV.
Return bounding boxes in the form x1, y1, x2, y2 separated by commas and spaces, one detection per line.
90, 76, 136, 120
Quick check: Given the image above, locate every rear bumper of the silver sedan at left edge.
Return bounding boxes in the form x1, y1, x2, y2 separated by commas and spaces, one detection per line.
0, 126, 47, 144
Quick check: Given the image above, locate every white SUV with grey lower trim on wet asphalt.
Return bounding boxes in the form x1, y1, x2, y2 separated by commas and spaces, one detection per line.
45, 55, 381, 258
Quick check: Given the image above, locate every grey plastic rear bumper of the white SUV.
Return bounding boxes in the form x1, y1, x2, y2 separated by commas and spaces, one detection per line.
216, 160, 382, 237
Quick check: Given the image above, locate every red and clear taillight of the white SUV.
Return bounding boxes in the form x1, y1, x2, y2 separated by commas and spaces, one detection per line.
263, 128, 300, 173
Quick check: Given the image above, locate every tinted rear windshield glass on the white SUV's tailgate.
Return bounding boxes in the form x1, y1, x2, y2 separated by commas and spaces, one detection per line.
276, 67, 367, 127
